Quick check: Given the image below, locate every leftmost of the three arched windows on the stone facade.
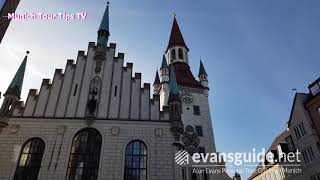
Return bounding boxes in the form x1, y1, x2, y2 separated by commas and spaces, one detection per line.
13, 138, 45, 180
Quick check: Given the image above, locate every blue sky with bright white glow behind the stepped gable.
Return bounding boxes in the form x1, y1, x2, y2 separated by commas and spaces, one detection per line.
0, 0, 320, 177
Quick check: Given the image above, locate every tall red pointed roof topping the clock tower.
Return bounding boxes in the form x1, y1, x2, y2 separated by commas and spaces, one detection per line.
167, 16, 189, 50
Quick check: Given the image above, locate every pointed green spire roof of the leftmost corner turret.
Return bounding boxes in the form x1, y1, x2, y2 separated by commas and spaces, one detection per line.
4, 51, 29, 98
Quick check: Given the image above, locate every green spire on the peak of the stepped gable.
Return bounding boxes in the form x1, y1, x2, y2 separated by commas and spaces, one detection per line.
97, 2, 110, 46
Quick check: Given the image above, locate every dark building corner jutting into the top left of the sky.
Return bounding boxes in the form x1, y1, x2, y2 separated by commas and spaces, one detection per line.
0, 0, 20, 43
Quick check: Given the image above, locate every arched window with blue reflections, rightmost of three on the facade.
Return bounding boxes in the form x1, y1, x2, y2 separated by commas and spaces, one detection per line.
124, 140, 147, 180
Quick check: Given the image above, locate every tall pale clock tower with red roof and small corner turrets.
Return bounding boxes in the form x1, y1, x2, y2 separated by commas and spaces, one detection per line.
159, 16, 222, 179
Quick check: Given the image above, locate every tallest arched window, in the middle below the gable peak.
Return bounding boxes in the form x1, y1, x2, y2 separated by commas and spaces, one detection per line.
66, 128, 102, 180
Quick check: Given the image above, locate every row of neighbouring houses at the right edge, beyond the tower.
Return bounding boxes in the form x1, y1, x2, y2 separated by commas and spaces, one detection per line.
249, 78, 320, 180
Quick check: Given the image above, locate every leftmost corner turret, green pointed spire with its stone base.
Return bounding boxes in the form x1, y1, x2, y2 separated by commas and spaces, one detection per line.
0, 51, 29, 116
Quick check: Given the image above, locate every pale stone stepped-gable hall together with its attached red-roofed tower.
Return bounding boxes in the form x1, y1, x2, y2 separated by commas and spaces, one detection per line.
0, 2, 232, 180
